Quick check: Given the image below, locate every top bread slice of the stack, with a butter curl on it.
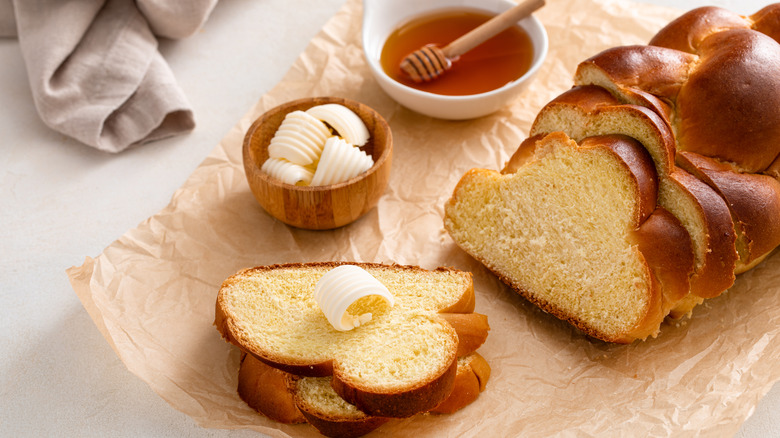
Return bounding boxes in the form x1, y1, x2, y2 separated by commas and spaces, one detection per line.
215, 263, 486, 417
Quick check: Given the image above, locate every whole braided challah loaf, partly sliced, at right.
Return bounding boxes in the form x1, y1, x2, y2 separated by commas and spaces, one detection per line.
444, 4, 780, 343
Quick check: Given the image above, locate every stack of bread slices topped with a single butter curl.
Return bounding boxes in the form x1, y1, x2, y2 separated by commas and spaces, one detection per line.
215, 262, 490, 437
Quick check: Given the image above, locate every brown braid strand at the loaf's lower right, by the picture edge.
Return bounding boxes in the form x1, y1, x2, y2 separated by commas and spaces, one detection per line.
677, 152, 780, 273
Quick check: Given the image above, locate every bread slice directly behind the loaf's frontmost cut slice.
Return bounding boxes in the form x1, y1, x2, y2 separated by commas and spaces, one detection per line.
524, 85, 738, 298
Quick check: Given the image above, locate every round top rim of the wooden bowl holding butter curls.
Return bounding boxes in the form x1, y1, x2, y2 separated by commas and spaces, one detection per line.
242, 96, 393, 192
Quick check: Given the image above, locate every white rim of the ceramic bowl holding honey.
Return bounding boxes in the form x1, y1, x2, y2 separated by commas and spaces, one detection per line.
362, 3, 549, 103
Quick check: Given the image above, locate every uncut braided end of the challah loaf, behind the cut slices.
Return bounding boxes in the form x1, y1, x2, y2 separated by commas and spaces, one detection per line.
575, 4, 780, 273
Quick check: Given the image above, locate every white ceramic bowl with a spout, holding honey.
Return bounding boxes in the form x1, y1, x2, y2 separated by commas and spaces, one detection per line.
363, 0, 548, 120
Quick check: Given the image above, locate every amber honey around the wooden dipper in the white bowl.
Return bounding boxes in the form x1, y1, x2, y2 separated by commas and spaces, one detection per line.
380, 9, 533, 96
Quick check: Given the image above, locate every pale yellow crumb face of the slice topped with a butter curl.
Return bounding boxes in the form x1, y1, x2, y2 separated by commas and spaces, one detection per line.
218, 264, 466, 392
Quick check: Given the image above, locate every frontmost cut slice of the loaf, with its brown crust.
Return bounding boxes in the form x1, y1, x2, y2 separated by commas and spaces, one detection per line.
444, 132, 693, 342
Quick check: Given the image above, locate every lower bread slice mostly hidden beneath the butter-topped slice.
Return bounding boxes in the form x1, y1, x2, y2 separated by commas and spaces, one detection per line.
238, 352, 490, 437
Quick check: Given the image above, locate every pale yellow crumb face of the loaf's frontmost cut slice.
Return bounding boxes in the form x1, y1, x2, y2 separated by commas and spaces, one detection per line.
445, 135, 652, 338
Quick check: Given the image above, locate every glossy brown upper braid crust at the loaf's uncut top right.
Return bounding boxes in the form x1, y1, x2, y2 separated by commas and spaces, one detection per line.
575, 4, 780, 177
